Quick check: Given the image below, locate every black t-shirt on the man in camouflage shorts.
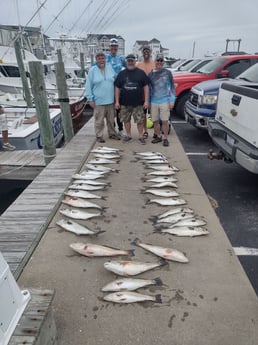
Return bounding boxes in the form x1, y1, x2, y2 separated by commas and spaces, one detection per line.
115, 67, 149, 107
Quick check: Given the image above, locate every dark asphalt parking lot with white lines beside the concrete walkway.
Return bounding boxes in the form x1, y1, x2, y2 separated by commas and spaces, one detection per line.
172, 114, 258, 294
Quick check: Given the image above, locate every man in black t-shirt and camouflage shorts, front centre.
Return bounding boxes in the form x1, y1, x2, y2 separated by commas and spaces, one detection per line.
115, 54, 149, 145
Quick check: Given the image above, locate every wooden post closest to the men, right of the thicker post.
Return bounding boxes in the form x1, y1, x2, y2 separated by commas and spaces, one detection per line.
55, 62, 74, 143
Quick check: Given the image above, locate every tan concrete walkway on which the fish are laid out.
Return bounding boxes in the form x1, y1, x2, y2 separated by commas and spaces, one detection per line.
18, 124, 258, 345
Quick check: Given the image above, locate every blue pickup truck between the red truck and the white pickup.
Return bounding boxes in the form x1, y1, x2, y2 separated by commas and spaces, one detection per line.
185, 56, 258, 130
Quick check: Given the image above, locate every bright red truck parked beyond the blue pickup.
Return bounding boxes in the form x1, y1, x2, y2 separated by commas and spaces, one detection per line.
173, 54, 258, 117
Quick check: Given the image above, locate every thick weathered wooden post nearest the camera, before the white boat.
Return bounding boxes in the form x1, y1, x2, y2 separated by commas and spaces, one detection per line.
29, 61, 56, 164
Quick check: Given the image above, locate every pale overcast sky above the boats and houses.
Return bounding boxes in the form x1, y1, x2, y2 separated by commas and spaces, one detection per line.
1, 0, 258, 58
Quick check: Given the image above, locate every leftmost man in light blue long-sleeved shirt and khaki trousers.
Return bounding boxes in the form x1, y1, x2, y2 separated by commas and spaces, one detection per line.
85, 52, 120, 143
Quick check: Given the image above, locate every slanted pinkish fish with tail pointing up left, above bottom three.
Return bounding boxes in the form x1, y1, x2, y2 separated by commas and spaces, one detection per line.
132, 238, 189, 263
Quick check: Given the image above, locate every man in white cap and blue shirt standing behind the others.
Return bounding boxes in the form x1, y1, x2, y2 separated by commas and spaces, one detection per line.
106, 38, 126, 137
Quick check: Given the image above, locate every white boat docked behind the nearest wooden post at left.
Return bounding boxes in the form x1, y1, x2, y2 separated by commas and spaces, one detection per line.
0, 108, 63, 150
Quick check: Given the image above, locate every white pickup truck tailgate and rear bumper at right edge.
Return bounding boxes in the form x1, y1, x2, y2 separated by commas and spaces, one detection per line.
208, 81, 258, 174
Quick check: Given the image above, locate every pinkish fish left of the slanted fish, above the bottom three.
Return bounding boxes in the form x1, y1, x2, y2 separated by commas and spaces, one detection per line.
70, 242, 134, 257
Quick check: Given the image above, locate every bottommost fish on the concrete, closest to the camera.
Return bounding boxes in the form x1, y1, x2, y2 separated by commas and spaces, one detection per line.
103, 291, 162, 303
